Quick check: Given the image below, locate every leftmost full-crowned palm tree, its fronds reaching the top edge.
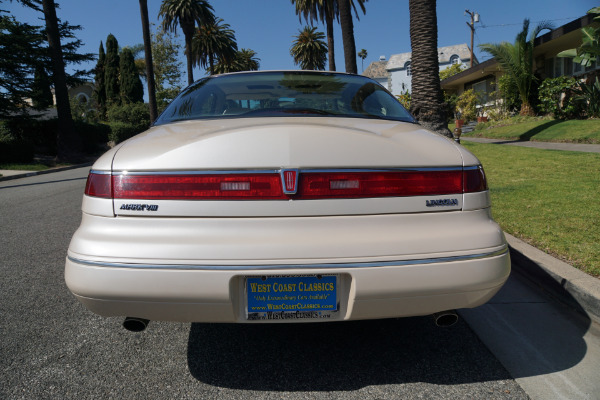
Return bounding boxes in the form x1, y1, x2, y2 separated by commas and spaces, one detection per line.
158, 0, 215, 85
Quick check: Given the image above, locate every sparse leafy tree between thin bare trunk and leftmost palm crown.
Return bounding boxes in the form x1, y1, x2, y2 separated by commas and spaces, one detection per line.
152, 27, 183, 111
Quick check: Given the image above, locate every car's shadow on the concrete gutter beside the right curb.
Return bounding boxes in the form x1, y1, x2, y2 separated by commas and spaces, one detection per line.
460, 255, 592, 382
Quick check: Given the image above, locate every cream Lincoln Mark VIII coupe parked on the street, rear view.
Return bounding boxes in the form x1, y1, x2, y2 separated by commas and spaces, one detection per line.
65, 71, 510, 329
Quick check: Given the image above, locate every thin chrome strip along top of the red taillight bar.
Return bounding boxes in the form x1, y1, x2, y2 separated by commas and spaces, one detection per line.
111, 166, 468, 176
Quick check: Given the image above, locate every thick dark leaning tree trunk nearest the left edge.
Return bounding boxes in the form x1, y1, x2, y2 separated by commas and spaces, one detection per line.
42, 0, 81, 162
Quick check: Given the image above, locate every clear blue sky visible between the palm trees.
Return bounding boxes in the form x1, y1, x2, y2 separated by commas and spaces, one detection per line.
0, 0, 598, 80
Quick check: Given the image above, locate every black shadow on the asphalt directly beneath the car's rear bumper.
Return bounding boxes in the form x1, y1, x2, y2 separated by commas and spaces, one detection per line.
188, 317, 511, 392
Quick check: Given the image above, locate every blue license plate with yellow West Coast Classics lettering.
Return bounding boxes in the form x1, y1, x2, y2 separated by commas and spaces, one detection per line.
246, 275, 338, 320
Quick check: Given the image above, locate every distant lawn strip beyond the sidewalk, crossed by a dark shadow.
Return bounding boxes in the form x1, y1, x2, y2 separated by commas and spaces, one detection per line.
464, 117, 600, 143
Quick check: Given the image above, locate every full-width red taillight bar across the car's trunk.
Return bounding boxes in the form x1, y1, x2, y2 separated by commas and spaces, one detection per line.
85, 167, 487, 200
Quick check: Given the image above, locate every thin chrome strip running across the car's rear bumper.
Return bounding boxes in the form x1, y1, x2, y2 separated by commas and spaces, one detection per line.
67, 245, 508, 271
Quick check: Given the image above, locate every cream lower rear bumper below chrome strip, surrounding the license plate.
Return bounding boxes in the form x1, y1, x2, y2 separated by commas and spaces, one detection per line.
65, 248, 510, 323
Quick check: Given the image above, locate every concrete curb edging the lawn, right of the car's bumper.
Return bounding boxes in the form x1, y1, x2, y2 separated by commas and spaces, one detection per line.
505, 233, 600, 324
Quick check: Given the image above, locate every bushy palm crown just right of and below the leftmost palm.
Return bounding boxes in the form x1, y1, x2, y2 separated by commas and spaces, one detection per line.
192, 18, 237, 75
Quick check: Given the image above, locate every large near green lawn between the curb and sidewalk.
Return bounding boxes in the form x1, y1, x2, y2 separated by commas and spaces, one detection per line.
463, 142, 600, 277
